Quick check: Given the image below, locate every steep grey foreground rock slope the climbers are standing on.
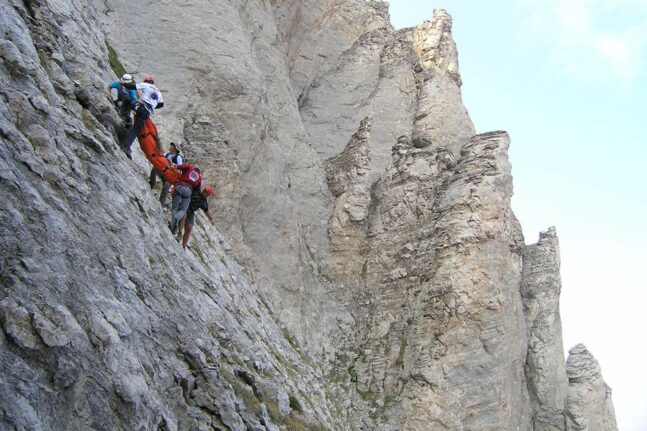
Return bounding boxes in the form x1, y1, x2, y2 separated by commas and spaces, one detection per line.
0, 2, 337, 430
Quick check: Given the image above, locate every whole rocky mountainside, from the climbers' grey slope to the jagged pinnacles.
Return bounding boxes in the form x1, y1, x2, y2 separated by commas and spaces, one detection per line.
0, 0, 616, 431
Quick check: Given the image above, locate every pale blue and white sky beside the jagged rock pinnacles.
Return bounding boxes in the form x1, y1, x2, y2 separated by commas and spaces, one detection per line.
389, 0, 647, 431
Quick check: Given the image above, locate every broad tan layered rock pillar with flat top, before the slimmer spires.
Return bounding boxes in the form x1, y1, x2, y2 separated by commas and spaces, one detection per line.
344, 132, 528, 430
